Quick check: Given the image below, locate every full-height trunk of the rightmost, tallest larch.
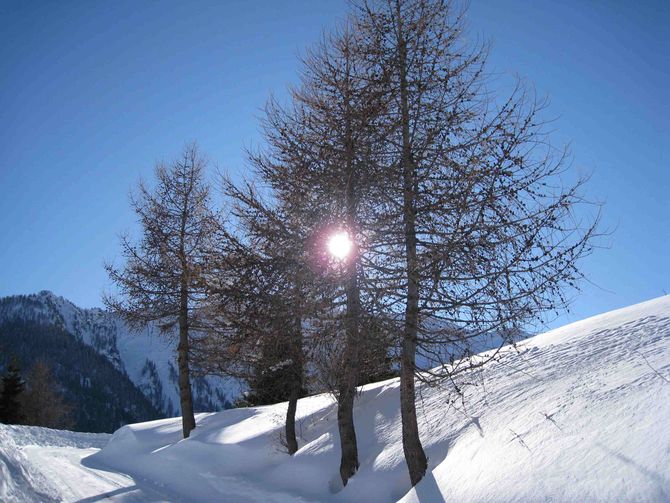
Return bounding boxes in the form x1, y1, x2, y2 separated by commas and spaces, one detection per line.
396, 1, 428, 486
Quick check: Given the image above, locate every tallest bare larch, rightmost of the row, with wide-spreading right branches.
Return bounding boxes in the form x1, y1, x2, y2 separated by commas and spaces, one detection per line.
355, 0, 597, 485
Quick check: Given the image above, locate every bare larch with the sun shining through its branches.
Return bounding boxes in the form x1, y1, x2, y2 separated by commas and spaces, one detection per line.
242, 25, 396, 485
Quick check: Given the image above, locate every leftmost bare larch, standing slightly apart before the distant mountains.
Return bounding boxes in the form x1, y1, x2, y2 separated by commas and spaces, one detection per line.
105, 144, 218, 438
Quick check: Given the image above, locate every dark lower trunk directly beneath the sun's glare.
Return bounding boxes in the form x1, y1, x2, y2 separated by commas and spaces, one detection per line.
337, 272, 360, 486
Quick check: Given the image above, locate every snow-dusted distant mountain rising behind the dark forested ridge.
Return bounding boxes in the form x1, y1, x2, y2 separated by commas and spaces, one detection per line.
0, 291, 240, 430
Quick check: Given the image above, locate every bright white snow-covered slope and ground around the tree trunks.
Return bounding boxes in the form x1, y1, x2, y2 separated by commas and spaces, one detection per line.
0, 296, 670, 503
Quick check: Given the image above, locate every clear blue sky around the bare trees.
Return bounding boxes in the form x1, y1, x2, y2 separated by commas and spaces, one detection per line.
0, 0, 670, 325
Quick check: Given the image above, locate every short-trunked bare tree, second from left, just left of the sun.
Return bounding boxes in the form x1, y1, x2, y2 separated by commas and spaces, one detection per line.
196, 177, 314, 454
